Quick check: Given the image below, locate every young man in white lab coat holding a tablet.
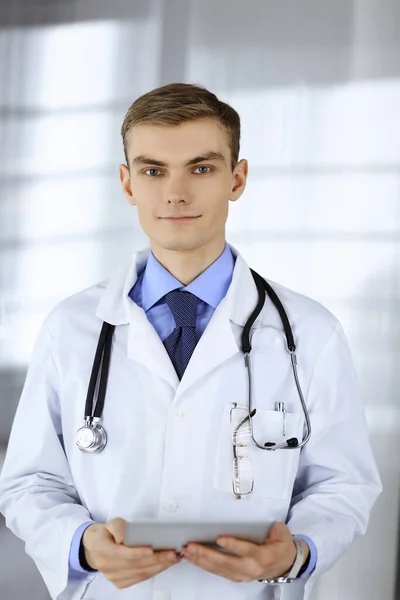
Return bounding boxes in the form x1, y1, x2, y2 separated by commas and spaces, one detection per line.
0, 84, 381, 600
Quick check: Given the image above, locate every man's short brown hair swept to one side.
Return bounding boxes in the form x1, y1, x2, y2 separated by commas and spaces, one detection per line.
121, 83, 240, 170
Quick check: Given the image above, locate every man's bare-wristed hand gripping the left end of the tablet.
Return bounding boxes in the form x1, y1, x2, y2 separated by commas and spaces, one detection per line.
82, 518, 181, 589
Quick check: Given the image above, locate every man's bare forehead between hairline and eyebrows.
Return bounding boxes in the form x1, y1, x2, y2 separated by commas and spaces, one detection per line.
127, 119, 230, 162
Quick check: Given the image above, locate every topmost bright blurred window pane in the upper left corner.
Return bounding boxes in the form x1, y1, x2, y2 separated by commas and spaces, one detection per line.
0, 16, 160, 108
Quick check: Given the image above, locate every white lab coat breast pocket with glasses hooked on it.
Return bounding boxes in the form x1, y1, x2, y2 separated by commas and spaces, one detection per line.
213, 404, 304, 498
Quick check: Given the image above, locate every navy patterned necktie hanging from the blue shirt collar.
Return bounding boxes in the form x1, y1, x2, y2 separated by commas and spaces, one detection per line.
164, 290, 199, 379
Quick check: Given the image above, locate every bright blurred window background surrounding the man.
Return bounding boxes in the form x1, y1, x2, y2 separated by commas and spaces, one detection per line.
0, 0, 400, 600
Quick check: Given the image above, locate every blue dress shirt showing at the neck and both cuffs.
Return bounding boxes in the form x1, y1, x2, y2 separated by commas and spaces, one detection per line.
69, 244, 317, 577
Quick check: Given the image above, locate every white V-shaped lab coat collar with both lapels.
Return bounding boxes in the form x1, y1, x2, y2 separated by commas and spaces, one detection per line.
96, 246, 264, 401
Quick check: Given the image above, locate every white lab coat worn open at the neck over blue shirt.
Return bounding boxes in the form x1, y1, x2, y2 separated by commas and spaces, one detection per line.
0, 249, 381, 600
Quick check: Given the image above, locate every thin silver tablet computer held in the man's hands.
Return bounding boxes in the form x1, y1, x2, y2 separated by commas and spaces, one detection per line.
124, 519, 274, 552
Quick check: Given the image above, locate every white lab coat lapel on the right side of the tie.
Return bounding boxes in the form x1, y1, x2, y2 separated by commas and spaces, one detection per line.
175, 251, 261, 399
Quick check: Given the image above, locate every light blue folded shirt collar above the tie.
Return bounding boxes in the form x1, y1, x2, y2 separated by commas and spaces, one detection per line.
142, 244, 235, 311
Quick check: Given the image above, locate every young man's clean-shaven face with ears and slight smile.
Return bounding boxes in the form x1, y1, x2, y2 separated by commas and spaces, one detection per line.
120, 118, 247, 251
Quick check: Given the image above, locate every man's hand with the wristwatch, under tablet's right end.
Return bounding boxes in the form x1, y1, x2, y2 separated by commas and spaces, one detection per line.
182, 523, 310, 582
